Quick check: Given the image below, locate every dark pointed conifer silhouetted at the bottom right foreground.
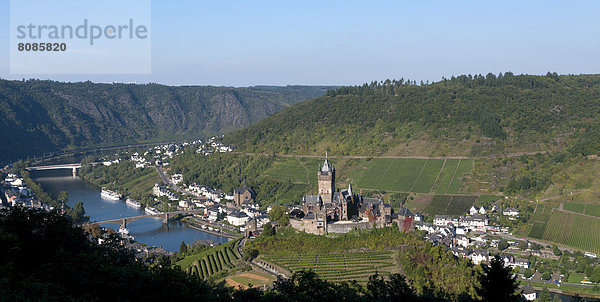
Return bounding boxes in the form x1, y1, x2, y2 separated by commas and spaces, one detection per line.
477, 256, 521, 302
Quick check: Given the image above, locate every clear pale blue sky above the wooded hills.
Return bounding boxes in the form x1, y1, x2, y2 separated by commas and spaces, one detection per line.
0, 0, 600, 86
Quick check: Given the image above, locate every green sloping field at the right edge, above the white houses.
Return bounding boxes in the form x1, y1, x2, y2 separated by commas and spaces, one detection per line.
529, 207, 600, 253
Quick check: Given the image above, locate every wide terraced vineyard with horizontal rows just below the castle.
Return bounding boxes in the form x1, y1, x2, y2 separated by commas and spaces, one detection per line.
264, 251, 397, 283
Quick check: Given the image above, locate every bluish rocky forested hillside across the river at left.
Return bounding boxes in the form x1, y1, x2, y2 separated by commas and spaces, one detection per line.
0, 80, 329, 162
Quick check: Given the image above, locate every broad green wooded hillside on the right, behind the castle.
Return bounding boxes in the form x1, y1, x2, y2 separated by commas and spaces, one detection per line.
226, 72, 600, 156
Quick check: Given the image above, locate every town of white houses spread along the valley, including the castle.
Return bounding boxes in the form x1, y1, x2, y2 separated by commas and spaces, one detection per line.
2, 137, 597, 300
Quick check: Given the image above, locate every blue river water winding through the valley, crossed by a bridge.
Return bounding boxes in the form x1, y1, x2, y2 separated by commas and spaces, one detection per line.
31, 170, 228, 252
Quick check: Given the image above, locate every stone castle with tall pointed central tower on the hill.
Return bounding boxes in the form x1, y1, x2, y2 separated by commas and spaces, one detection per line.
291, 156, 413, 234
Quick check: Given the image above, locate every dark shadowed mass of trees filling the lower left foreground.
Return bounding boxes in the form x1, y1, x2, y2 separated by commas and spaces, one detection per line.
0, 207, 217, 301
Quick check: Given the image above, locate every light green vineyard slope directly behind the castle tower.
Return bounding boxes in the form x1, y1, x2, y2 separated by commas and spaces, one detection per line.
265, 157, 473, 194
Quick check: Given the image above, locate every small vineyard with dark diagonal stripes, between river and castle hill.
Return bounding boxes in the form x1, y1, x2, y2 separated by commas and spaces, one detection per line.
176, 240, 240, 279
